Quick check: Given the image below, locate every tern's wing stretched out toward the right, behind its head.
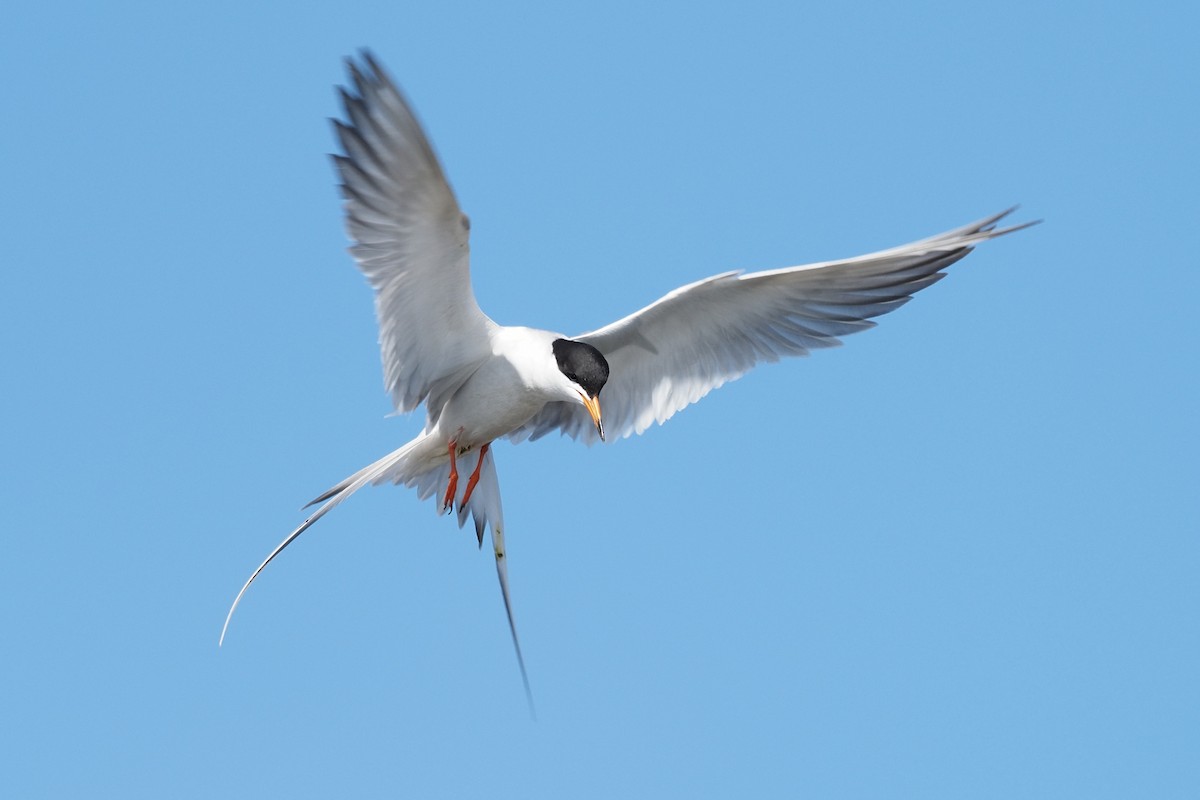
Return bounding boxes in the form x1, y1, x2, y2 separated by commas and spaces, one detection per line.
511, 209, 1033, 444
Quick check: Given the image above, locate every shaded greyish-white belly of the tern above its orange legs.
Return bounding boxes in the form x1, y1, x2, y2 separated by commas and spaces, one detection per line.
437, 360, 547, 447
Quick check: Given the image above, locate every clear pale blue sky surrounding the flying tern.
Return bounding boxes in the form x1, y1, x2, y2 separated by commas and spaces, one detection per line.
0, 1, 1200, 798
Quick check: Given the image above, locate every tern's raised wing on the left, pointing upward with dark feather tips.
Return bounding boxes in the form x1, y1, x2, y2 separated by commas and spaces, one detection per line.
334, 53, 494, 413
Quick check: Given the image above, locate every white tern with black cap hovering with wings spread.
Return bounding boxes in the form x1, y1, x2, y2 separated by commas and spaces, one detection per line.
221, 52, 1034, 709
